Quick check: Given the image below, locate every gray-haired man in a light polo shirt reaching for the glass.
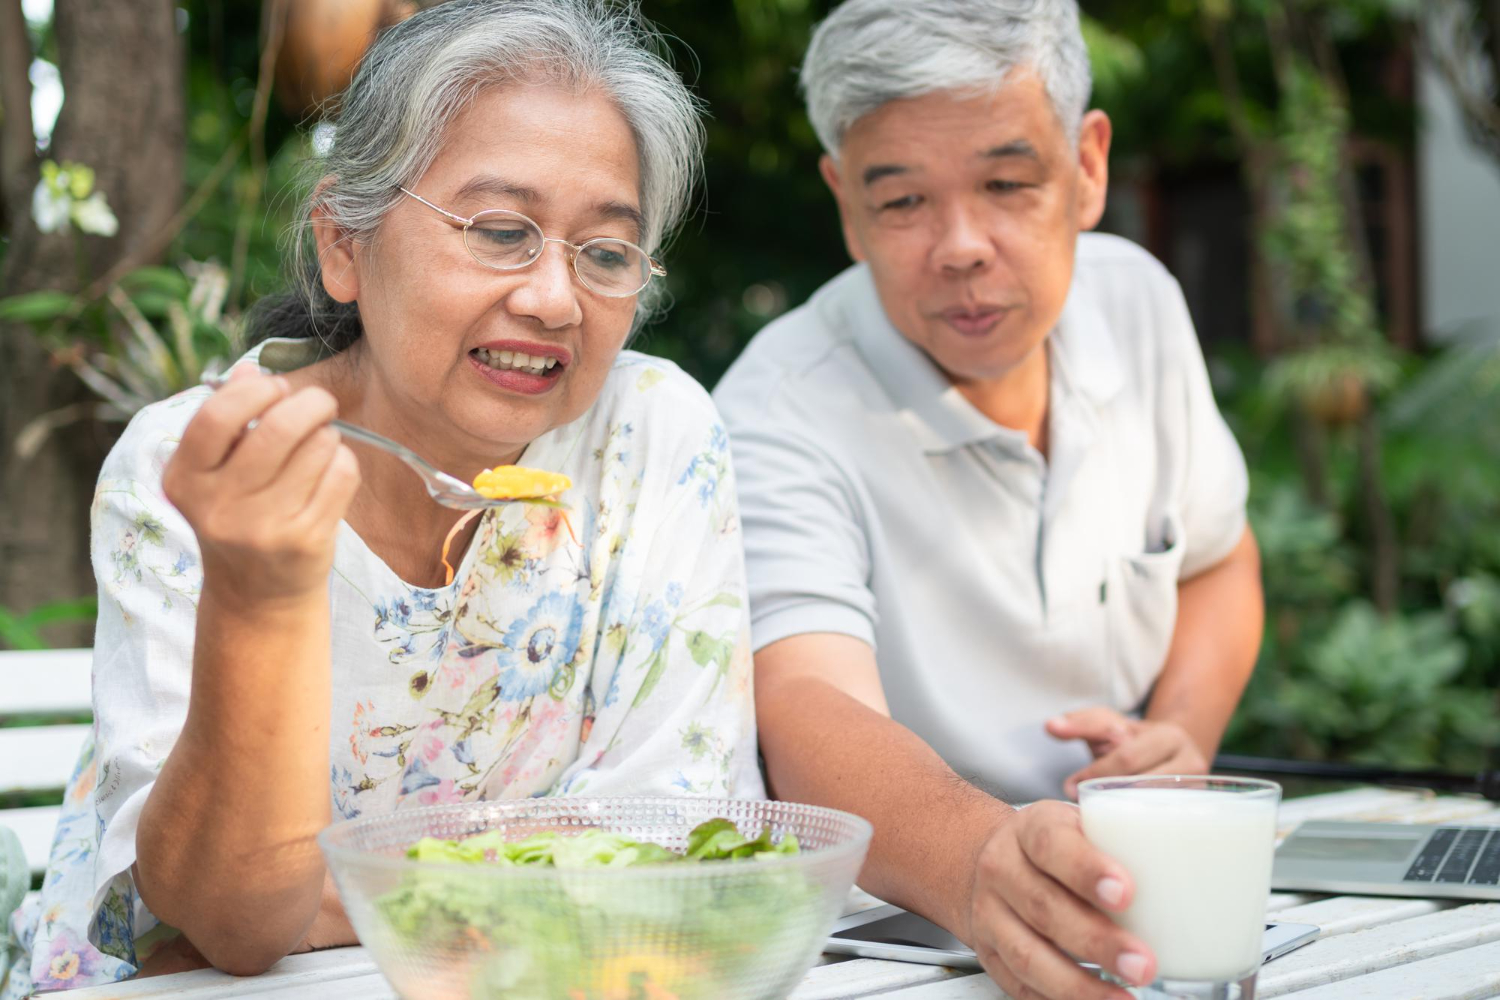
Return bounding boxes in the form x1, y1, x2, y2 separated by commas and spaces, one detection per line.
716, 0, 1262, 1000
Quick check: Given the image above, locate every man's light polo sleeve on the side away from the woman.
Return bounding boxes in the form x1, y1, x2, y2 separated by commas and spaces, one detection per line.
1163, 276, 1250, 580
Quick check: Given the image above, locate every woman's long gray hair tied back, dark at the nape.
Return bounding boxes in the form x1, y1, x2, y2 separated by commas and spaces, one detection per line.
255, 0, 704, 351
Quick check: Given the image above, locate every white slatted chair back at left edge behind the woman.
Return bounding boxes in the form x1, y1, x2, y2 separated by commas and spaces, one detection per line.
0, 649, 93, 874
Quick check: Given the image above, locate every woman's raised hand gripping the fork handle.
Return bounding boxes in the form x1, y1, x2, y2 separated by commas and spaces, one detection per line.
162, 367, 360, 604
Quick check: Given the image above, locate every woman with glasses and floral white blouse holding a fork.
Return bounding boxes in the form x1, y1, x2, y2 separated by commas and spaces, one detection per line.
5, 0, 762, 997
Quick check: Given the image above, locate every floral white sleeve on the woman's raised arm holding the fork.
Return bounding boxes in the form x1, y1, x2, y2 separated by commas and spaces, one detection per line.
90, 397, 203, 957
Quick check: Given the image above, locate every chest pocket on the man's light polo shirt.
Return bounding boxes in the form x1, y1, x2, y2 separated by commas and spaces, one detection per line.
1104, 514, 1185, 711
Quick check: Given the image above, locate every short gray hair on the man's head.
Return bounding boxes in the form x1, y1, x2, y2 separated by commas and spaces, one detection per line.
803, 0, 1094, 159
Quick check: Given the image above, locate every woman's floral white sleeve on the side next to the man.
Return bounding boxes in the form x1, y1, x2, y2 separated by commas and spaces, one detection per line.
555, 395, 765, 798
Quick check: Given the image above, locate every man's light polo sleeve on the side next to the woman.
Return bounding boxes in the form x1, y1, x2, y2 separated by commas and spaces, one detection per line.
732, 421, 878, 651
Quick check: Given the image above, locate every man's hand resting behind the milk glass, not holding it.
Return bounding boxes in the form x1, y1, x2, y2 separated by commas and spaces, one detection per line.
1047, 708, 1209, 799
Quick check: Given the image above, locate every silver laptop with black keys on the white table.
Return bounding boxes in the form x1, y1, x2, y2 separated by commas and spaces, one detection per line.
1271, 820, 1500, 900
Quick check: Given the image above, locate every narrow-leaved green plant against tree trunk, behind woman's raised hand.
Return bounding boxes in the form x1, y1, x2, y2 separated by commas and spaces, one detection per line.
0, 261, 243, 459
